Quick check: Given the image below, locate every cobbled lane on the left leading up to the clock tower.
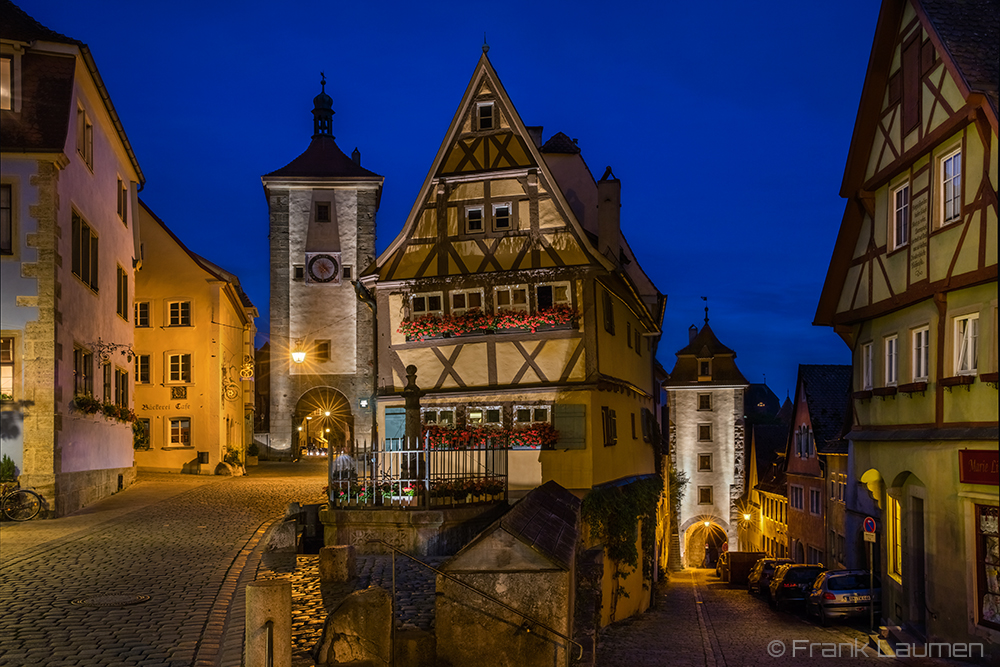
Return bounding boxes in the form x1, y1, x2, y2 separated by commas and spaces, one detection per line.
0, 476, 325, 667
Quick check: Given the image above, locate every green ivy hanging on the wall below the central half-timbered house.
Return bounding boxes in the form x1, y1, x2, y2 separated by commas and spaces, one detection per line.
582, 476, 663, 621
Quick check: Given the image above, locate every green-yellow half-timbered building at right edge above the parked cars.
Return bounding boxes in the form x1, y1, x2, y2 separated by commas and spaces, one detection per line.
816, 0, 1000, 647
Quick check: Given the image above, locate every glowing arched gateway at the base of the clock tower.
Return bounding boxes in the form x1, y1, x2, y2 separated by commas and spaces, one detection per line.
292, 387, 354, 457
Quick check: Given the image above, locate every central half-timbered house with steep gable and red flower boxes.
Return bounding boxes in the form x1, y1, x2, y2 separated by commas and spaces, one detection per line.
360, 52, 666, 615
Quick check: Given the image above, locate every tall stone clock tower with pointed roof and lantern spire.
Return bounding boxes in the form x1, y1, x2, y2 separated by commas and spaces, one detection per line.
261, 78, 383, 454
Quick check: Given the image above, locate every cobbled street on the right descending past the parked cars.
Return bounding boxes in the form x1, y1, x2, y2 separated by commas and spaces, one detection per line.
597, 569, 985, 667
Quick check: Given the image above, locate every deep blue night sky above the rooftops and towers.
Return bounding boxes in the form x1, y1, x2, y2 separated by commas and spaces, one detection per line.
13, 0, 879, 398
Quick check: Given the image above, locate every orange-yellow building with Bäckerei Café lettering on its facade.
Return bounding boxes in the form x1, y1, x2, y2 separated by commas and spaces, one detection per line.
134, 202, 257, 474
